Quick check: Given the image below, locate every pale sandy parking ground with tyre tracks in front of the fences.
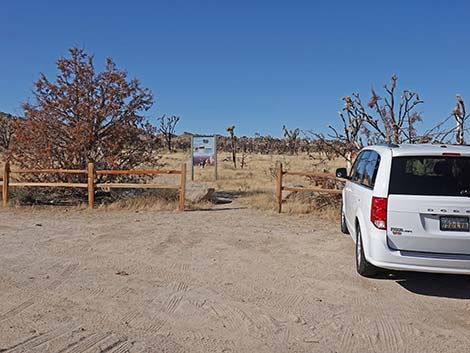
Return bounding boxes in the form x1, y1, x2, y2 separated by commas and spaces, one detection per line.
0, 205, 470, 353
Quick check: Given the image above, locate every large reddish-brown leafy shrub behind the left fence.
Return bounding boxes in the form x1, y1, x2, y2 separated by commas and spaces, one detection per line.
10, 48, 154, 169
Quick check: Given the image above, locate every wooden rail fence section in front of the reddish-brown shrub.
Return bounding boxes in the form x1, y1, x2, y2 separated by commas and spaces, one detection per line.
2, 162, 186, 211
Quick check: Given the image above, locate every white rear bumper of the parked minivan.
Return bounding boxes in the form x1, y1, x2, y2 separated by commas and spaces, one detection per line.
366, 230, 470, 274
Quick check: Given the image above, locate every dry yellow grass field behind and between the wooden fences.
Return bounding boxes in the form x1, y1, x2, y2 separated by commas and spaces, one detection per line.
0, 151, 346, 220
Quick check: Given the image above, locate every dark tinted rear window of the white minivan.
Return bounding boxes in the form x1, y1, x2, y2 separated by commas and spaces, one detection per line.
389, 156, 470, 196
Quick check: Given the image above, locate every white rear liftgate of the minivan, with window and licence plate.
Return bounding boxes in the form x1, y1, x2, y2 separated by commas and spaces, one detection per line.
387, 155, 470, 254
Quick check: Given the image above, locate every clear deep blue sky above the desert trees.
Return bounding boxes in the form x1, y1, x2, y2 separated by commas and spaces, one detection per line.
0, 0, 470, 135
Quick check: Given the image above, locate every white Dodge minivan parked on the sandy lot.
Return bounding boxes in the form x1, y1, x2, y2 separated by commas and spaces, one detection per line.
336, 144, 470, 277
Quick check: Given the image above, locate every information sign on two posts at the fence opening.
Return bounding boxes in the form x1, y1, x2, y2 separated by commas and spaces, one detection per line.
191, 135, 217, 180
